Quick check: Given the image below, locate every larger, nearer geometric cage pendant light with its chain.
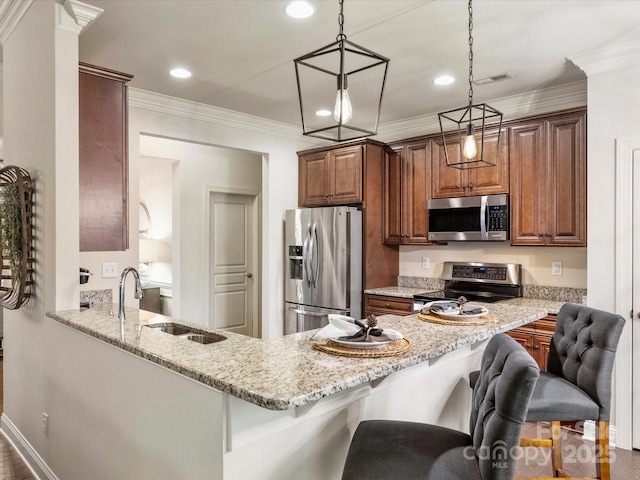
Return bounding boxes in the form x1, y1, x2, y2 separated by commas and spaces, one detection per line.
294, 0, 389, 142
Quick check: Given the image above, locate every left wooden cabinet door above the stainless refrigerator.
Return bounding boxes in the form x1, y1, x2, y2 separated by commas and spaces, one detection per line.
298, 152, 331, 207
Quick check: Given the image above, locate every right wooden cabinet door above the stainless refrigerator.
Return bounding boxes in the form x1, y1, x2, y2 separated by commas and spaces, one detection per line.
329, 146, 362, 204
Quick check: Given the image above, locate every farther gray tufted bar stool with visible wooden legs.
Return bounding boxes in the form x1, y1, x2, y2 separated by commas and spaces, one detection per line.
520, 303, 625, 480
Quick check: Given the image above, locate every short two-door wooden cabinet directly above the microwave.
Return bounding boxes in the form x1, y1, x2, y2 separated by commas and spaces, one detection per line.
431, 128, 509, 198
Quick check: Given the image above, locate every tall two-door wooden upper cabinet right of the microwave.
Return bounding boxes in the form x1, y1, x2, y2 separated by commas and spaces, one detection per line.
509, 110, 587, 246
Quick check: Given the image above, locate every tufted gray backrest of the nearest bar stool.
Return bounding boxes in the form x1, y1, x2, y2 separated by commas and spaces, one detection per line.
470, 333, 540, 480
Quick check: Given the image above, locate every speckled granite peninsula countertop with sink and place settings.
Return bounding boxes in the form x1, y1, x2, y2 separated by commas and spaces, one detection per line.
47, 304, 547, 410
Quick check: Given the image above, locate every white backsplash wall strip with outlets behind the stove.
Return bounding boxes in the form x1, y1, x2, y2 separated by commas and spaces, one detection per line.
400, 246, 587, 288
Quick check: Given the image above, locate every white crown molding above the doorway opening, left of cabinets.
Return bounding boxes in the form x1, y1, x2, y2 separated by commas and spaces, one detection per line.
129, 87, 328, 146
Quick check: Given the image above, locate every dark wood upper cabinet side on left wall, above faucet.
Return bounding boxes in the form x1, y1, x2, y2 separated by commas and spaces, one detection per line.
79, 63, 133, 252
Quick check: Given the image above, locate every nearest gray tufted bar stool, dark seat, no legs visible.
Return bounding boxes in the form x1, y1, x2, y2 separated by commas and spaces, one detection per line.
342, 333, 540, 480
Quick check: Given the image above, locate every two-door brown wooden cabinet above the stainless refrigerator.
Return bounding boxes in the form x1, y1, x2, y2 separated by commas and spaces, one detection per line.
298, 146, 362, 207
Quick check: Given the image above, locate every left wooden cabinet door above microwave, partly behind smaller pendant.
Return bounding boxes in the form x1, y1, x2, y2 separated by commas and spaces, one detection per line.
431, 138, 469, 198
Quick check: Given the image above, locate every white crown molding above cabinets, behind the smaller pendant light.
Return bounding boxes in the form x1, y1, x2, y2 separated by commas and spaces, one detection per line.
375, 80, 587, 142
